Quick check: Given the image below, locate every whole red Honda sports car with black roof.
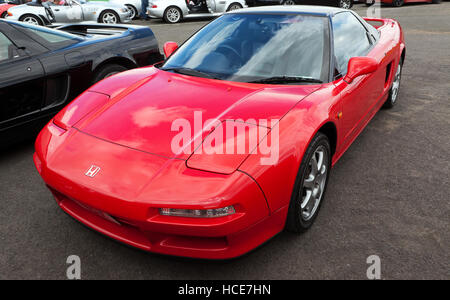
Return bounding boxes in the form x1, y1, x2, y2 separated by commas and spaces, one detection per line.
34, 6, 405, 259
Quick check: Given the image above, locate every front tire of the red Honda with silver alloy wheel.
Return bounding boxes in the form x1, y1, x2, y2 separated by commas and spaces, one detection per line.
286, 132, 331, 233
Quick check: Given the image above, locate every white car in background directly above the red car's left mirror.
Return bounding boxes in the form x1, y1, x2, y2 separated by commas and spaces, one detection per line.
147, 0, 247, 23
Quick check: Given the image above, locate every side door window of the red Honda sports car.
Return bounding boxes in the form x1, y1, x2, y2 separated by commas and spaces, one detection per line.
333, 12, 371, 75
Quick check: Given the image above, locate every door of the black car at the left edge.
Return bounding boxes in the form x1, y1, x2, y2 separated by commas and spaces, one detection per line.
0, 27, 45, 131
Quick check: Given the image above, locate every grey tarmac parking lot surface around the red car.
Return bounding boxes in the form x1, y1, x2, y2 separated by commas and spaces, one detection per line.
0, 2, 450, 279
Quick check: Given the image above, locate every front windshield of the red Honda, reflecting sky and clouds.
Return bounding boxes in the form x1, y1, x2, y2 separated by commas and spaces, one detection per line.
161, 13, 329, 83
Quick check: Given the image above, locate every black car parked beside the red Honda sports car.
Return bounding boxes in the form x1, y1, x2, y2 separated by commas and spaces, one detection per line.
0, 20, 163, 145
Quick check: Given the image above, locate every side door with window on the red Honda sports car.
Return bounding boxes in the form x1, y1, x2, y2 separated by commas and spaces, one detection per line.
332, 12, 384, 146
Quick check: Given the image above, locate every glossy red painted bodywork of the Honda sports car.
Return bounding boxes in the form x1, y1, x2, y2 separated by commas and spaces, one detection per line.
34, 20, 404, 259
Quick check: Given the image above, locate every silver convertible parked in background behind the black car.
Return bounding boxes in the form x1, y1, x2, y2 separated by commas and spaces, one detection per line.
7, 0, 132, 25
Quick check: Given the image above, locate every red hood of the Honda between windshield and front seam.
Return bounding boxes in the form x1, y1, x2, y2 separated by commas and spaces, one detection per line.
75, 68, 320, 159
